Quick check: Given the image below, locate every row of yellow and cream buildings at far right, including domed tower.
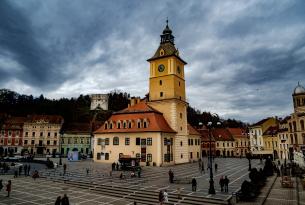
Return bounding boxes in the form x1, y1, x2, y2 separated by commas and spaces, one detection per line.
249, 84, 305, 159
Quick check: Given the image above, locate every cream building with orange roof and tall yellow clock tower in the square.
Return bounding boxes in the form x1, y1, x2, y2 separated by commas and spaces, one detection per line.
94, 23, 201, 166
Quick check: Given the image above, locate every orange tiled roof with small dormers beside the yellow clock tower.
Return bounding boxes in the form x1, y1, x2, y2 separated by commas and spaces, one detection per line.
94, 101, 176, 134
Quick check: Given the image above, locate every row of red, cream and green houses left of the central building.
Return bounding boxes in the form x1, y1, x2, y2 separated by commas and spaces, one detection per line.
0, 115, 92, 155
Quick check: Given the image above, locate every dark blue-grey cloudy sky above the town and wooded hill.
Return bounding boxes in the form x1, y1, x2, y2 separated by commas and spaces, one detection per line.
0, 0, 305, 122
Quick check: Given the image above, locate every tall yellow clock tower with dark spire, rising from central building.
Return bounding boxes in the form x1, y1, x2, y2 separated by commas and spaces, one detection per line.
147, 21, 188, 163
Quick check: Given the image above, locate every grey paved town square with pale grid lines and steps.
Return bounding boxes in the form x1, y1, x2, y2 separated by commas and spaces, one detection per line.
0, 158, 302, 205
